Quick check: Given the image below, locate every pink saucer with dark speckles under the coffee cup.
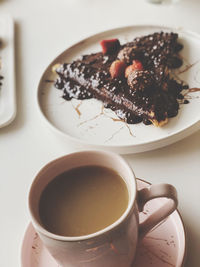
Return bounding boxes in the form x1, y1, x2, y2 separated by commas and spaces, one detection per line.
21, 179, 186, 267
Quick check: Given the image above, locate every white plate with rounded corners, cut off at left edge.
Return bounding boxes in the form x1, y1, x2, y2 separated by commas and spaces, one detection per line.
0, 16, 16, 127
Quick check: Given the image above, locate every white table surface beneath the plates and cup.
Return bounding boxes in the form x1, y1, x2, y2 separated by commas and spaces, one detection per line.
0, 0, 200, 267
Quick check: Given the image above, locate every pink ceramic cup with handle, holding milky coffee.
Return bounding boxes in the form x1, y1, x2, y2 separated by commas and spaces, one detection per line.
29, 151, 177, 267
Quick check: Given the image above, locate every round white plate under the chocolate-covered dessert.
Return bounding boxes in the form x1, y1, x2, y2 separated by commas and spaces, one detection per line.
38, 26, 200, 153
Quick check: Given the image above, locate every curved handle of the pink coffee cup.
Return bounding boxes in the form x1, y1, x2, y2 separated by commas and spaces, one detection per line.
137, 184, 178, 238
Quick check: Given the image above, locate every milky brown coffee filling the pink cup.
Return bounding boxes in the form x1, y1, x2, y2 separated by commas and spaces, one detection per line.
39, 166, 129, 236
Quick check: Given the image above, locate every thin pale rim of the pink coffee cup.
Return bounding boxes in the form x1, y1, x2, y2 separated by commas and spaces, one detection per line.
28, 150, 137, 242
